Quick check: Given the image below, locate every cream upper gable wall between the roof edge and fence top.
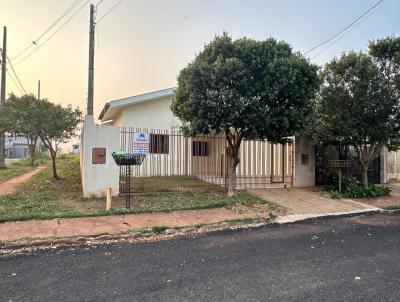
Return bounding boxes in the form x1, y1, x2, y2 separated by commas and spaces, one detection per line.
119, 96, 181, 130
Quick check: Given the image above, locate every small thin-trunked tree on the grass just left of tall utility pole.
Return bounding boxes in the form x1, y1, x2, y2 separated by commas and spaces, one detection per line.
35, 99, 82, 179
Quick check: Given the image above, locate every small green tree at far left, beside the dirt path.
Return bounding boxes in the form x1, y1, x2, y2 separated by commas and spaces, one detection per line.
0, 94, 40, 166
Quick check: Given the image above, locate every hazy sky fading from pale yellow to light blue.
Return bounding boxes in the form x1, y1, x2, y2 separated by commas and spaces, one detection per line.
0, 0, 400, 118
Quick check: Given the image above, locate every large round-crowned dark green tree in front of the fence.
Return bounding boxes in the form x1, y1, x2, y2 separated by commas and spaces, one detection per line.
171, 33, 318, 196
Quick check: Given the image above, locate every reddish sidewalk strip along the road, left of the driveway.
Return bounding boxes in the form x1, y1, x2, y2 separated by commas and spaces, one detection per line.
0, 208, 258, 241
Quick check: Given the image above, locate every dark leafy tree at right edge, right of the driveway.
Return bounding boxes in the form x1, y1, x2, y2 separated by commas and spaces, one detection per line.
312, 52, 400, 186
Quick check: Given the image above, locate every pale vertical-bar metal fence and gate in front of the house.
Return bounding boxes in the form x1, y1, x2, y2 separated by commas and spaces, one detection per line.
120, 127, 293, 193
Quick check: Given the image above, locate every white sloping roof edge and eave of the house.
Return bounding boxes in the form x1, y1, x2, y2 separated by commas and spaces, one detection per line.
99, 87, 176, 122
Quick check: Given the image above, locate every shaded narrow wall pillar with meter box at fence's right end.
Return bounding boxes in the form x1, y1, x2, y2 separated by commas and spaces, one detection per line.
293, 136, 315, 188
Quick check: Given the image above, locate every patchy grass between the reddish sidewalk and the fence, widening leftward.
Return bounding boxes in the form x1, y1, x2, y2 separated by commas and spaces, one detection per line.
0, 155, 276, 222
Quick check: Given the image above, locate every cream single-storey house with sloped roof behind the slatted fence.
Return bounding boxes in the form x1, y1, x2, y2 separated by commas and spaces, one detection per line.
84, 88, 314, 196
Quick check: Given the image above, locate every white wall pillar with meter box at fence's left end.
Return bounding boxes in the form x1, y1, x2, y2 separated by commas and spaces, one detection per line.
81, 116, 120, 197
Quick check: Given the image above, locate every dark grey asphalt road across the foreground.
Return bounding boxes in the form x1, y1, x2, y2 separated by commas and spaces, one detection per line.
0, 215, 400, 301
